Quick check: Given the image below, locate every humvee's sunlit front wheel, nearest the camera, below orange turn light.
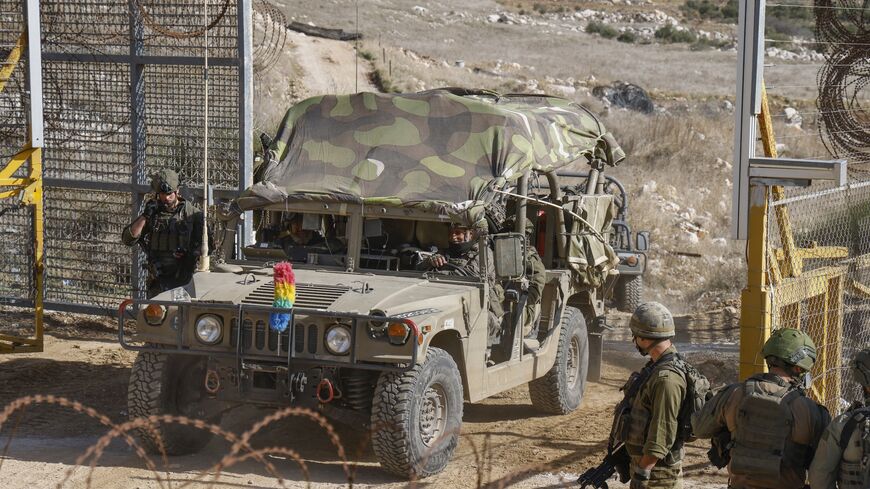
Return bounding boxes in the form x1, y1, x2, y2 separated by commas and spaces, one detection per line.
371, 347, 463, 479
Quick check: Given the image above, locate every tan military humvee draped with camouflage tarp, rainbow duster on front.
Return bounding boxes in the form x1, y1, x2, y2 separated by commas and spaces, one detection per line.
120, 89, 624, 477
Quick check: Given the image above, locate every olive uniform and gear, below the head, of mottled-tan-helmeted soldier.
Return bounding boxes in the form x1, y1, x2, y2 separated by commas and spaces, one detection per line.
625, 346, 686, 489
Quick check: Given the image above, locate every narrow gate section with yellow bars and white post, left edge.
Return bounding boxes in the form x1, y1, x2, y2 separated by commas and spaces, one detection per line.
0, 0, 44, 353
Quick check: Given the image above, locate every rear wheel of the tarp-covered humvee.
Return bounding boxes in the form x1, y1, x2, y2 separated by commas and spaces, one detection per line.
529, 307, 589, 414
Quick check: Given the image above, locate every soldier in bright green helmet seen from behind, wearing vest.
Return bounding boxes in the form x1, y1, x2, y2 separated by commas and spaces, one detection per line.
692, 328, 831, 489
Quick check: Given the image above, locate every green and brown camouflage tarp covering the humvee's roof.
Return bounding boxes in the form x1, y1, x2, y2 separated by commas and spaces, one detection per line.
238, 90, 625, 224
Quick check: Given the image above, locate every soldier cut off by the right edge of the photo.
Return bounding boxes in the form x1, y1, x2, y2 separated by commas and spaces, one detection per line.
810, 348, 870, 489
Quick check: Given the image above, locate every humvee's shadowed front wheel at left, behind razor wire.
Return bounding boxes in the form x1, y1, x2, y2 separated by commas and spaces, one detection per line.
127, 351, 221, 455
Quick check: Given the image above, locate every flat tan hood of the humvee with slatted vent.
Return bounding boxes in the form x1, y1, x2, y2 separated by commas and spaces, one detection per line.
185, 268, 478, 316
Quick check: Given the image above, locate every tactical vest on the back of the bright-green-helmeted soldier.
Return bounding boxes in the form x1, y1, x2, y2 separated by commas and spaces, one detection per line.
730, 379, 812, 487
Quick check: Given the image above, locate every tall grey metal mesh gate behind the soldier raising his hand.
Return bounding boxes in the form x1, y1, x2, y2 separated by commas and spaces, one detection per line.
0, 0, 253, 324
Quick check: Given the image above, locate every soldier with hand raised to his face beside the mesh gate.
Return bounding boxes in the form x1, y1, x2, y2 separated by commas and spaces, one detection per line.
121, 170, 212, 299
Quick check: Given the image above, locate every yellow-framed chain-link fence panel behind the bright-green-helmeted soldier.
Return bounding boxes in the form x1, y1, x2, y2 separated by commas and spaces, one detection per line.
768, 179, 870, 412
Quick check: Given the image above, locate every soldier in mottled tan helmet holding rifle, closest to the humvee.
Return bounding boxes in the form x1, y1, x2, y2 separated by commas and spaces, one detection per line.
614, 302, 687, 489
